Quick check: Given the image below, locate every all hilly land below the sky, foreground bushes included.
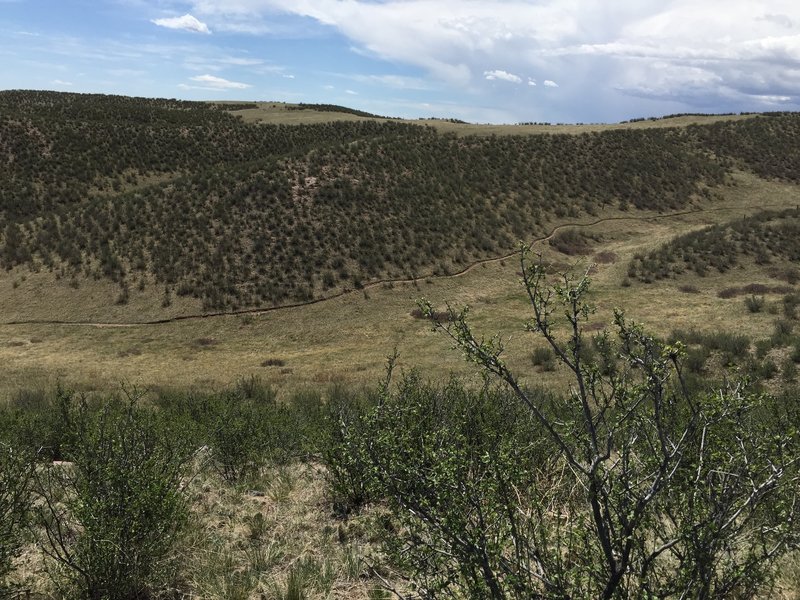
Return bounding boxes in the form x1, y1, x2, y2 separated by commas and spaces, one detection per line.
0, 92, 800, 599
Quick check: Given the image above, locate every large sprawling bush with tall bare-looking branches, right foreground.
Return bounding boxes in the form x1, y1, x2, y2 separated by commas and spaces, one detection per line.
330, 246, 798, 599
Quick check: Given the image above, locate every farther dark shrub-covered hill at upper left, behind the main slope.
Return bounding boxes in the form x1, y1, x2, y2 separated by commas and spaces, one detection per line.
0, 91, 376, 220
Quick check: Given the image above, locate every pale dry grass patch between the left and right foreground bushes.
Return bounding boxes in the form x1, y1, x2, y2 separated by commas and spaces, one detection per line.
181, 464, 390, 600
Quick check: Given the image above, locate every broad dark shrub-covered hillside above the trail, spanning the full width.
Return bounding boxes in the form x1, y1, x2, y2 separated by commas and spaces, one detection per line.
0, 92, 800, 309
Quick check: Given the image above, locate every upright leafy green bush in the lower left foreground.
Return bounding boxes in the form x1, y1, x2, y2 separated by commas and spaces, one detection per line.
37, 398, 191, 600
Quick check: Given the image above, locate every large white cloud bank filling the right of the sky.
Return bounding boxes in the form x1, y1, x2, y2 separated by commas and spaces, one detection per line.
188, 0, 800, 118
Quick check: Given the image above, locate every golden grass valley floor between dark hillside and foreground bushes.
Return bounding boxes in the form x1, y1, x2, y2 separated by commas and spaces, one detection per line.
0, 174, 798, 394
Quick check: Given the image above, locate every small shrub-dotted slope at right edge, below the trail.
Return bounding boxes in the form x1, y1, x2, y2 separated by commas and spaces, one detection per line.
628, 209, 800, 283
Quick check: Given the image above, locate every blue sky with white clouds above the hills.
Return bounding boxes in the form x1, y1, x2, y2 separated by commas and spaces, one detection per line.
0, 0, 800, 123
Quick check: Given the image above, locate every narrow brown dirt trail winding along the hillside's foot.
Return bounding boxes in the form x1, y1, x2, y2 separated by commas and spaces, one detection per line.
0, 203, 788, 328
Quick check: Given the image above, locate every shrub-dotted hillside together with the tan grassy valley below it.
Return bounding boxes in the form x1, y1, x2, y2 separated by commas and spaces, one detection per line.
0, 92, 800, 389
